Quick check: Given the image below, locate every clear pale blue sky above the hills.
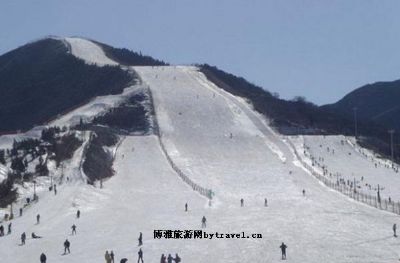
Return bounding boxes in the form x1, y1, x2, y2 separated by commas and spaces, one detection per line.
0, 0, 400, 104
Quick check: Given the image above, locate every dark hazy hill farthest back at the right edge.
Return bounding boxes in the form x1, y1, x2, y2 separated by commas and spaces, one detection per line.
322, 80, 400, 131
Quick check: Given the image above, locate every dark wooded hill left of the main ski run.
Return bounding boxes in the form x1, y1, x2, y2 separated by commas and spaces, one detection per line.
0, 38, 133, 132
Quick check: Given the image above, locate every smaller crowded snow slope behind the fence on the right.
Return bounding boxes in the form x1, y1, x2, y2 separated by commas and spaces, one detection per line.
292, 136, 400, 202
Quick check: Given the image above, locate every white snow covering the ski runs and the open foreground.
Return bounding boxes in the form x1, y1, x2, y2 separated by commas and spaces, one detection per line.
0, 38, 400, 263
